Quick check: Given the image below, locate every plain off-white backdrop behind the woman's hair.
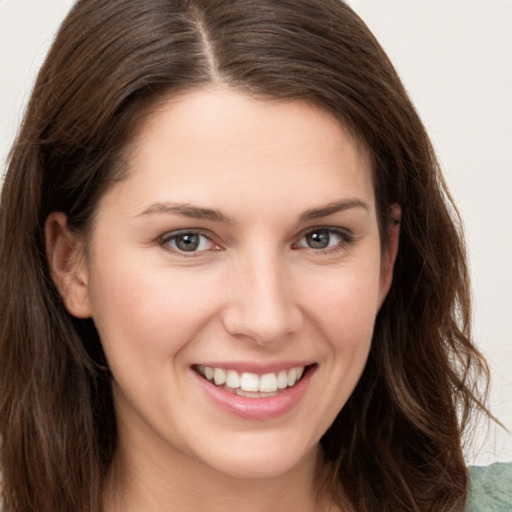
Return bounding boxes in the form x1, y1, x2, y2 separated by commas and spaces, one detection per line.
0, 0, 512, 464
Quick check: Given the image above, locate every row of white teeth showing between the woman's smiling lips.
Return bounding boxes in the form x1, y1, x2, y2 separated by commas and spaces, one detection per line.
193, 365, 312, 398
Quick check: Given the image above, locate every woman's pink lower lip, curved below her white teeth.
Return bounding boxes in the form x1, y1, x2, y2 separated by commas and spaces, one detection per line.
192, 367, 315, 420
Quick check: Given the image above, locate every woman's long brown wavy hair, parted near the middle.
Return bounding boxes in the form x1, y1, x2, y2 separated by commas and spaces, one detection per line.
0, 0, 488, 512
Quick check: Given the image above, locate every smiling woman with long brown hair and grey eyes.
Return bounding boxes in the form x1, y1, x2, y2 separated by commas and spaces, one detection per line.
0, 0, 506, 512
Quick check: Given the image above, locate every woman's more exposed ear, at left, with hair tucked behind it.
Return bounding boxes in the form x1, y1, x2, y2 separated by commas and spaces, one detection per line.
44, 212, 91, 318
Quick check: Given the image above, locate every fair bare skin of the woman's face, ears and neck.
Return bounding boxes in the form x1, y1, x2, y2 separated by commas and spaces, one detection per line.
46, 87, 399, 511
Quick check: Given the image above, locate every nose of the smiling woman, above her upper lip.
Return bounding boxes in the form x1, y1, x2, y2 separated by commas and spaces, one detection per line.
223, 250, 303, 345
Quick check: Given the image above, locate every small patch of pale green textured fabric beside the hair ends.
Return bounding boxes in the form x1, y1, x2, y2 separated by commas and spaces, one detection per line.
466, 462, 512, 512
